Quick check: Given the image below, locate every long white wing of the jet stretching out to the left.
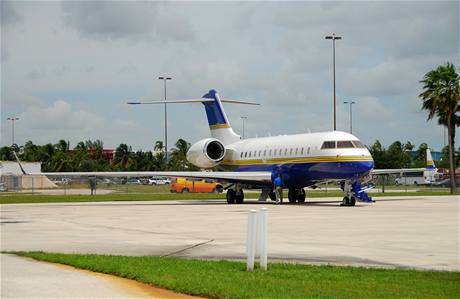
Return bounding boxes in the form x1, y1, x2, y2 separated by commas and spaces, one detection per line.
34, 171, 272, 185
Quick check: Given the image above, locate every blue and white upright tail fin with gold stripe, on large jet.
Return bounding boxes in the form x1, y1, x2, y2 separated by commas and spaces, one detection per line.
203, 89, 241, 145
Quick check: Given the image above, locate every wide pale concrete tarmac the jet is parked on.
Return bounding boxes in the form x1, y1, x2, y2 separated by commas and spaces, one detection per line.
0, 195, 460, 271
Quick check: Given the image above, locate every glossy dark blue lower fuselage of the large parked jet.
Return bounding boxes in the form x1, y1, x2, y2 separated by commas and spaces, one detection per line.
237, 161, 374, 188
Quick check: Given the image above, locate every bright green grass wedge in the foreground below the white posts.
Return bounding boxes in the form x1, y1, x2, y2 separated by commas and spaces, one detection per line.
12, 252, 460, 298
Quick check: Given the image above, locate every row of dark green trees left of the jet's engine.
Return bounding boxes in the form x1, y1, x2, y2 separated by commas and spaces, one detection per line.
0, 139, 198, 172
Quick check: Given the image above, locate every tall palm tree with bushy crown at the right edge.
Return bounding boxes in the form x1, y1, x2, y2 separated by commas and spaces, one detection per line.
419, 62, 460, 194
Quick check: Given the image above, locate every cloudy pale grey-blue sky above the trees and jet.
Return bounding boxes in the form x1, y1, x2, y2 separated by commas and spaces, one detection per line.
0, 1, 460, 150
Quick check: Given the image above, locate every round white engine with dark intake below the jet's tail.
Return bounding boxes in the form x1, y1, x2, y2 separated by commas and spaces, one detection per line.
187, 138, 225, 168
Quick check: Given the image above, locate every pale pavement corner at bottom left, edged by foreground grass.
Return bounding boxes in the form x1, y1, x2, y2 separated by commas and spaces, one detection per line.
1, 254, 201, 299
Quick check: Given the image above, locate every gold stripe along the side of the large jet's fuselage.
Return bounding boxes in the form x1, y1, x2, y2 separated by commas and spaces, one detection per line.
222, 156, 374, 165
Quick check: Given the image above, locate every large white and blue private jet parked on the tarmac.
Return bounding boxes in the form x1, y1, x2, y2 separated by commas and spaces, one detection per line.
31, 90, 435, 206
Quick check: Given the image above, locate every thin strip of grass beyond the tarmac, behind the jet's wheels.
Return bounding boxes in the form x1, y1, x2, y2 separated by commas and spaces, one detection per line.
0, 190, 449, 204
